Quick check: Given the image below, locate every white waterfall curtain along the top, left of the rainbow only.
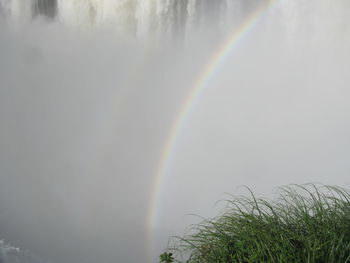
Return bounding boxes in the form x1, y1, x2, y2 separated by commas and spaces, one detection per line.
0, 0, 245, 37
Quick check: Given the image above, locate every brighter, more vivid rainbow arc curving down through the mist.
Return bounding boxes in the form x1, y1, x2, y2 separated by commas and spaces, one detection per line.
147, 0, 281, 260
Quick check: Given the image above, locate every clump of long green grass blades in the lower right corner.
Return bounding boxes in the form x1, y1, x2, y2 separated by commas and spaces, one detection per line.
161, 184, 350, 263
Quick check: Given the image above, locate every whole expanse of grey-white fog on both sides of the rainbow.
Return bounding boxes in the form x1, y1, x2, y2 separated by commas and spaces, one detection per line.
0, 0, 350, 263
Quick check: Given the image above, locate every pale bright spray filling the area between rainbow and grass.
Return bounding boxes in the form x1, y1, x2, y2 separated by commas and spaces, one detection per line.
154, 4, 350, 258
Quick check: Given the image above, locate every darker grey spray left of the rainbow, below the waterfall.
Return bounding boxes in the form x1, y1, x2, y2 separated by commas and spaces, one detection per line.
0, 8, 219, 262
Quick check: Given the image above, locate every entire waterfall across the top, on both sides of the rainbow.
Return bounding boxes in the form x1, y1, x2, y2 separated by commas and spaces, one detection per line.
0, 0, 350, 40
